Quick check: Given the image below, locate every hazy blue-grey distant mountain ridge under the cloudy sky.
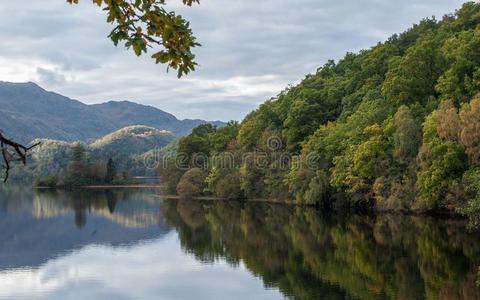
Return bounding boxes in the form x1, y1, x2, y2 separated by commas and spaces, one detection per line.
0, 81, 224, 143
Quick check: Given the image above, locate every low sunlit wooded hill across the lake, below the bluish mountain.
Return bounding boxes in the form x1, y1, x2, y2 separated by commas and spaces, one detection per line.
12, 125, 175, 186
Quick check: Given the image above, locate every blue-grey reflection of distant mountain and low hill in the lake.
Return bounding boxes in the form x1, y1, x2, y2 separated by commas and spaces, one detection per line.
0, 187, 170, 270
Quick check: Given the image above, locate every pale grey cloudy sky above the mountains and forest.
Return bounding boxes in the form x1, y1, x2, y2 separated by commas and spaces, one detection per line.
0, 0, 464, 121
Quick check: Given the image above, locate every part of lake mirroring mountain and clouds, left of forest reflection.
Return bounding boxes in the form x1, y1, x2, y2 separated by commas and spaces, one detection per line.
0, 189, 283, 299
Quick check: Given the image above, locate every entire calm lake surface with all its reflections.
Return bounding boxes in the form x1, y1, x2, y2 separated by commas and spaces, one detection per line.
0, 187, 480, 300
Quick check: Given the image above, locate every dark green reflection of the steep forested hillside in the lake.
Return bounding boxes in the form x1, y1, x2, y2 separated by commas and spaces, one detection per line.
162, 201, 480, 300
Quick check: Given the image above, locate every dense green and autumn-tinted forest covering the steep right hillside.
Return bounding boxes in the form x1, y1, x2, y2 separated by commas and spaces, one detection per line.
160, 2, 480, 222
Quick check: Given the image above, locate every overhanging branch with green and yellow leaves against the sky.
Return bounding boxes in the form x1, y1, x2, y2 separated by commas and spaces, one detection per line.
67, 0, 200, 78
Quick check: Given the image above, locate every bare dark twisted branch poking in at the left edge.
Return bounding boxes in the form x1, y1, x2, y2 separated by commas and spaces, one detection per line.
0, 131, 40, 182
